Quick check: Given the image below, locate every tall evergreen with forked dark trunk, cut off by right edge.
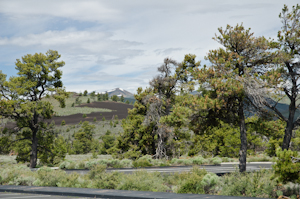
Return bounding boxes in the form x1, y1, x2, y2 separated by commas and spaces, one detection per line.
252, 4, 300, 150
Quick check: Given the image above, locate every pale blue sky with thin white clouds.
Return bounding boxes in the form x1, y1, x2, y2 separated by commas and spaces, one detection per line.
0, 0, 297, 93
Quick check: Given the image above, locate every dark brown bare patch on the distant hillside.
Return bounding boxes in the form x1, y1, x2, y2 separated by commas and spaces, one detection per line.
6, 101, 133, 128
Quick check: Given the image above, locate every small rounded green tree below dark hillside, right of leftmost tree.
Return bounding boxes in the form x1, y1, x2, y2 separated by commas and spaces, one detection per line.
73, 121, 95, 154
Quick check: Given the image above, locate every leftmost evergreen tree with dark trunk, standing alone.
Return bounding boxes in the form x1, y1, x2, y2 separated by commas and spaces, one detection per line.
0, 50, 67, 168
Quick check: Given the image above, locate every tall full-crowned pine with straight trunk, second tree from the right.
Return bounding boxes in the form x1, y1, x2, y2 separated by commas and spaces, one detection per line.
191, 25, 273, 172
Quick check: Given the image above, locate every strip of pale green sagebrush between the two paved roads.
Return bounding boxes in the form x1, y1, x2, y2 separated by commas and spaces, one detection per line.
0, 165, 299, 198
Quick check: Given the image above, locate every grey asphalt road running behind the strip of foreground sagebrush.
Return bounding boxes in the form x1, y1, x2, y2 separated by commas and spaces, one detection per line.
66, 162, 273, 175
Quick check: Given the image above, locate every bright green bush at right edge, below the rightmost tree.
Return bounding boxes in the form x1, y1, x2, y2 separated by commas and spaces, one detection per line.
273, 148, 300, 183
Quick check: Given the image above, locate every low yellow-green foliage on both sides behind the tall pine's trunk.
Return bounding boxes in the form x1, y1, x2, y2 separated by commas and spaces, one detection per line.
188, 117, 264, 157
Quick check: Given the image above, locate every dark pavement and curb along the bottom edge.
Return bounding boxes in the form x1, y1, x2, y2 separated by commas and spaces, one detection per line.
0, 185, 270, 199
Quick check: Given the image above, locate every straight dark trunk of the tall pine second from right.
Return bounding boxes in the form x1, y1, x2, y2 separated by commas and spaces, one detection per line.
238, 101, 247, 172
